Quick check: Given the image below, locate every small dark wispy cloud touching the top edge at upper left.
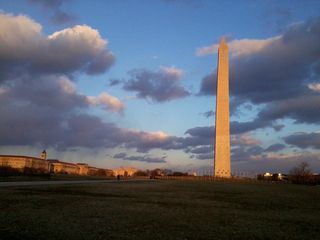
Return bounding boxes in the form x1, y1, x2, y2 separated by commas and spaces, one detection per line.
28, 0, 77, 25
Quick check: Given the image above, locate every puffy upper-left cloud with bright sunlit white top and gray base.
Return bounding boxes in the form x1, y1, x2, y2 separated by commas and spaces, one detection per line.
0, 13, 115, 74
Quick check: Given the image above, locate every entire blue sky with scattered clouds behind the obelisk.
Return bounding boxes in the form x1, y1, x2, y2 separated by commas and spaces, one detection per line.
0, 0, 320, 175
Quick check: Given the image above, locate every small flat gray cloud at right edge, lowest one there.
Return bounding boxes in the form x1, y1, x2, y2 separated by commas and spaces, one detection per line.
283, 132, 320, 149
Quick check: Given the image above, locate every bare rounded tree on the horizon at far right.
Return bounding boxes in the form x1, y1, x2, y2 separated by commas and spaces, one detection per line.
289, 162, 314, 184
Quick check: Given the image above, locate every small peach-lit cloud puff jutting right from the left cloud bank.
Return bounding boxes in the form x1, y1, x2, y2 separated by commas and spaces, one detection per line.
87, 92, 124, 112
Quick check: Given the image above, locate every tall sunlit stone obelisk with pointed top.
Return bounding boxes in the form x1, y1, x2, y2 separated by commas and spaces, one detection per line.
214, 38, 231, 178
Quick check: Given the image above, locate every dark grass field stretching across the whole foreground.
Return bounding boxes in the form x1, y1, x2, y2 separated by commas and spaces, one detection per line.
0, 180, 320, 240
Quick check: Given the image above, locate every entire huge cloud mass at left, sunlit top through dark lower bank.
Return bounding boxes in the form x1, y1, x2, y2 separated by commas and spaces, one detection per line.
0, 13, 130, 150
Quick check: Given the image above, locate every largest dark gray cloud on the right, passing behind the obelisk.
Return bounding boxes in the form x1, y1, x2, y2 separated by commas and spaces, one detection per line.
200, 18, 320, 125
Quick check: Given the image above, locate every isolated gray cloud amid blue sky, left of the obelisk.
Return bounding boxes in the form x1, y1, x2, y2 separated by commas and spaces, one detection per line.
123, 67, 190, 102
